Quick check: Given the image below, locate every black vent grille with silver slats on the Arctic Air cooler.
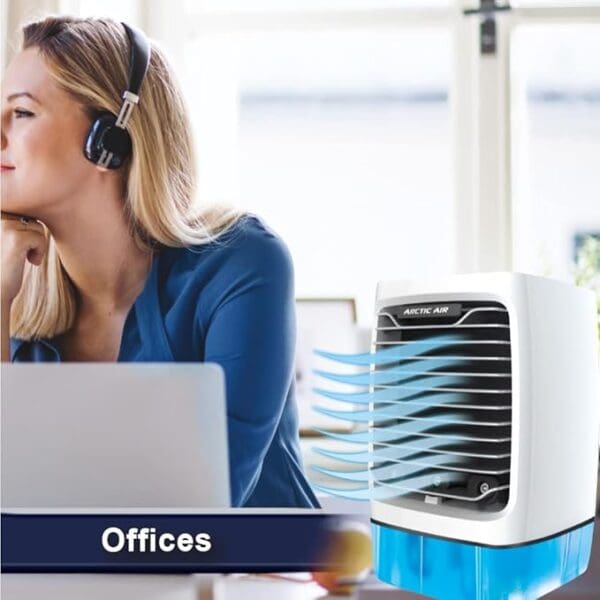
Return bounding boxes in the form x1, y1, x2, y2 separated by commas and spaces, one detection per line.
370, 301, 512, 511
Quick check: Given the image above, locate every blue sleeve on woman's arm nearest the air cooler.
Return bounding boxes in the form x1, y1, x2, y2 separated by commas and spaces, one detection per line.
200, 223, 296, 506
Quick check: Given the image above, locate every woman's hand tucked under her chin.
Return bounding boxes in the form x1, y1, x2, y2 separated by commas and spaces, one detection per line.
1, 212, 48, 304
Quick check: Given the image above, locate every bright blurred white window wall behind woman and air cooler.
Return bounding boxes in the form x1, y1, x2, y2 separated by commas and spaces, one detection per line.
1, 0, 600, 492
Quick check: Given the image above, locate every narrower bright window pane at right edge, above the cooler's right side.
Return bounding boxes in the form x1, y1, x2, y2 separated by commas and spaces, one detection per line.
513, 24, 600, 281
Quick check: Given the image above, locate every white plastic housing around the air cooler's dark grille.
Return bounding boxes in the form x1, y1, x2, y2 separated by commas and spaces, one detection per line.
371, 272, 600, 546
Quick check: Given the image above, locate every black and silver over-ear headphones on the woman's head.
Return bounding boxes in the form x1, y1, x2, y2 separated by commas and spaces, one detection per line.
83, 23, 150, 169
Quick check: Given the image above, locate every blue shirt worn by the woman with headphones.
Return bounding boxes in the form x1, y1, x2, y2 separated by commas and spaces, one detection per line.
11, 215, 319, 507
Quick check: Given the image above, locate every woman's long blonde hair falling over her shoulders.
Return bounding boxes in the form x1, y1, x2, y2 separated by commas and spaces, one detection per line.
10, 16, 243, 340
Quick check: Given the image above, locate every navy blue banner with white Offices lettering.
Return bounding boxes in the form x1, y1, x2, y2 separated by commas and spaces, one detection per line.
2, 513, 340, 573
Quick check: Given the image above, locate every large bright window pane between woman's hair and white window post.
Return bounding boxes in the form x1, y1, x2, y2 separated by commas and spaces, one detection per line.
204, 29, 453, 324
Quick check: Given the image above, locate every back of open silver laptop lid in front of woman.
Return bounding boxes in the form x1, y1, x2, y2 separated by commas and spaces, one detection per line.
0, 363, 230, 512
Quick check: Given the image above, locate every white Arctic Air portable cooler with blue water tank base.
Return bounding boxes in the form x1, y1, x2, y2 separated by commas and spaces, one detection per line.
369, 272, 600, 600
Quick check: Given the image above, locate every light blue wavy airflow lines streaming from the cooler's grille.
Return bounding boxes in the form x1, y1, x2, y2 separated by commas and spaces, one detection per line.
313, 333, 468, 500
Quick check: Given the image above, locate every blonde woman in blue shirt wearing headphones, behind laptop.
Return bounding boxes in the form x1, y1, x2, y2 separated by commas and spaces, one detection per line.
1, 17, 318, 507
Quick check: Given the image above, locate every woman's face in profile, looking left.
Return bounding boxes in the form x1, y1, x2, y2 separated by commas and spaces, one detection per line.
1, 48, 98, 221
